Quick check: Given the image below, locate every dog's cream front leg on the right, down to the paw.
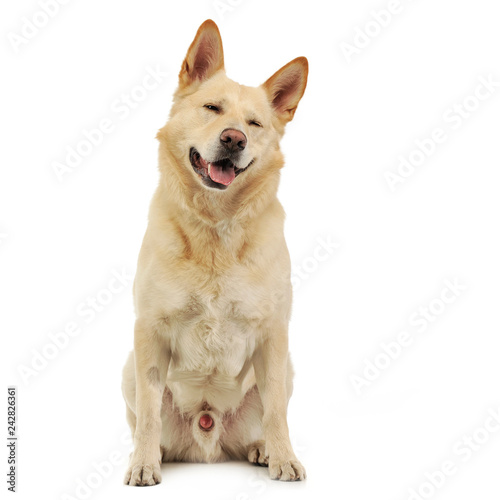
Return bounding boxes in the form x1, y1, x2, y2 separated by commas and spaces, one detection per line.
254, 326, 306, 481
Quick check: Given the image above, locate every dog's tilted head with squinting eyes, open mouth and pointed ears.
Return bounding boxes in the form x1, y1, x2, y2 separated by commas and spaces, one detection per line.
159, 20, 308, 190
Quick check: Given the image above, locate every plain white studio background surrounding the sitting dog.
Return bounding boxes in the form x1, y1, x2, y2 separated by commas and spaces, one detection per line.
0, 0, 500, 500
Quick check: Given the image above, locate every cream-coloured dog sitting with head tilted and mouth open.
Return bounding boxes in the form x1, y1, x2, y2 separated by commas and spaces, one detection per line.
122, 20, 308, 486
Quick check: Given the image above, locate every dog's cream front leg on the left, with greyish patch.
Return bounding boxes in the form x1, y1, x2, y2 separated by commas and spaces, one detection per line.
125, 320, 170, 486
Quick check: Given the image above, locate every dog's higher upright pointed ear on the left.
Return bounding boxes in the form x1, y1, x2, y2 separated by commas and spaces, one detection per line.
179, 19, 224, 87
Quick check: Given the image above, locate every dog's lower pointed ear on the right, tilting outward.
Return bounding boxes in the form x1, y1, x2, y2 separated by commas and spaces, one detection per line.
262, 57, 309, 123
